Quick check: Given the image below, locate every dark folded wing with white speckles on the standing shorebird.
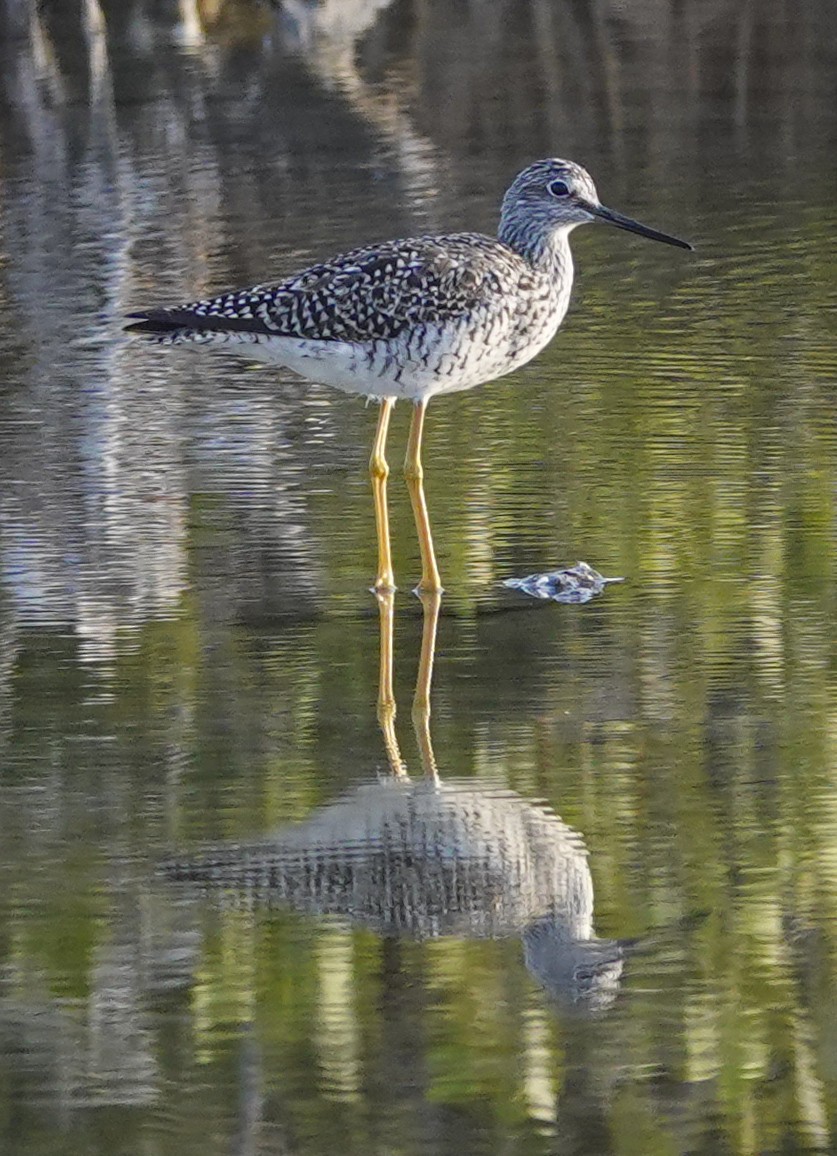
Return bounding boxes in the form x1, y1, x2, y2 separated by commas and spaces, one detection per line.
128, 234, 519, 342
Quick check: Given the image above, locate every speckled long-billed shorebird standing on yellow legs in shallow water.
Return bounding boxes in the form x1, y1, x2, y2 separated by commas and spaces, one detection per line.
127, 158, 691, 591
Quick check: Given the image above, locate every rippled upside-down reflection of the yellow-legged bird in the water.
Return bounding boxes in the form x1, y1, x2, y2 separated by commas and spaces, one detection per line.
165, 592, 623, 1008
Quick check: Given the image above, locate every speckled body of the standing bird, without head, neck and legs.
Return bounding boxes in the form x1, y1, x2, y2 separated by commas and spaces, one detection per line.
126, 234, 572, 399
